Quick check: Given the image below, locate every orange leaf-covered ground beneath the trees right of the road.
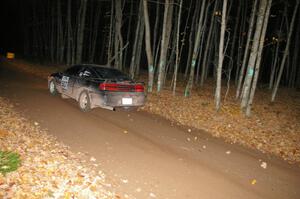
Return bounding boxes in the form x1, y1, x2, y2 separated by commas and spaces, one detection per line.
142, 78, 300, 164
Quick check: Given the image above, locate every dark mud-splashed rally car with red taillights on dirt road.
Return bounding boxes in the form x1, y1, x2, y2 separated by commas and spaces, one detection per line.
48, 64, 145, 111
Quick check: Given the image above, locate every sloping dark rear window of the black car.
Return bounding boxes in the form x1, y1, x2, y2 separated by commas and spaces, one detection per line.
93, 67, 132, 81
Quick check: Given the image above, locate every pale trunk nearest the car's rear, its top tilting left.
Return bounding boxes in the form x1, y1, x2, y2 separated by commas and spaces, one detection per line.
143, 0, 154, 92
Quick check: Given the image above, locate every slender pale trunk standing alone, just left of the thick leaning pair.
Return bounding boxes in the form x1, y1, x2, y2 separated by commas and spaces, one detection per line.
215, 0, 227, 111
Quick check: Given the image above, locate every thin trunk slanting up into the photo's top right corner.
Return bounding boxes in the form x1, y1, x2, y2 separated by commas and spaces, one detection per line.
271, 0, 300, 102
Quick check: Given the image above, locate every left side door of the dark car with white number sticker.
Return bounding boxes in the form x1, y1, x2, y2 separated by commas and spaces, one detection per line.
61, 66, 82, 97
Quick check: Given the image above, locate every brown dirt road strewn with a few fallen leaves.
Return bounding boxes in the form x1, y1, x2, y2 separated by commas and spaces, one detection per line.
0, 63, 300, 199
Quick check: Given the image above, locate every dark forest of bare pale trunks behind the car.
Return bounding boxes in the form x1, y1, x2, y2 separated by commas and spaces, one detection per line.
22, 0, 300, 115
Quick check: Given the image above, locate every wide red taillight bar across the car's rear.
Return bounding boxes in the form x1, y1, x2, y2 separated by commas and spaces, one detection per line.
99, 83, 144, 92
